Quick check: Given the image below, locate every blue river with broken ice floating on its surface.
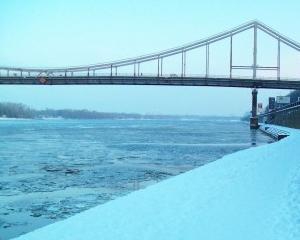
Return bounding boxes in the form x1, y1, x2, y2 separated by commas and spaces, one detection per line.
0, 118, 272, 240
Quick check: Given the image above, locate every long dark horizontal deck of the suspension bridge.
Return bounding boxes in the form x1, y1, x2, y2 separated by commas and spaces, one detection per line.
0, 76, 300, 89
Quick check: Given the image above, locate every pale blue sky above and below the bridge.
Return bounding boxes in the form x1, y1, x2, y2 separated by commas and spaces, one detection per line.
0, 0, 300, 115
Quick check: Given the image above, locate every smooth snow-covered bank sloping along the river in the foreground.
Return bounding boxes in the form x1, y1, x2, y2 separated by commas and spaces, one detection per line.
14, 125, 300, 240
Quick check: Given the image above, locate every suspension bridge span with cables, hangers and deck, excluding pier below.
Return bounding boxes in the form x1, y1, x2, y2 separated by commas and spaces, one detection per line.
0, 21, 300, 89
